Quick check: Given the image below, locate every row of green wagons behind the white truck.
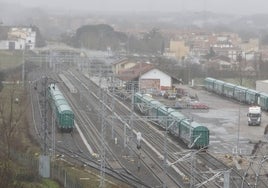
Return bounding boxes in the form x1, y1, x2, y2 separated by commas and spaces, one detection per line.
204, 77, 268, 111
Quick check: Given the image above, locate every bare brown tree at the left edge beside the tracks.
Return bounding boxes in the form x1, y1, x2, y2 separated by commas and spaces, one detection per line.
0, 83, 25, 187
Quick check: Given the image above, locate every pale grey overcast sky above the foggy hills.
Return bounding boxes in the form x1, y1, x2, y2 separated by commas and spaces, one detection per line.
3, 0, 268, 15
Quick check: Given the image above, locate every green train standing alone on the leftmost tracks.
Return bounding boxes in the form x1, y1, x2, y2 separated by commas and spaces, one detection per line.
48, 84, 74, 133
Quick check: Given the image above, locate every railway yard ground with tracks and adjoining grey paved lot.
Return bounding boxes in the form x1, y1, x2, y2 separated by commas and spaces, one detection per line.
28, 61, 268, 188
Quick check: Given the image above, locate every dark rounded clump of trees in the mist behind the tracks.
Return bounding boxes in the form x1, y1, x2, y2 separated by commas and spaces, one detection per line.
61, 24, 166, 54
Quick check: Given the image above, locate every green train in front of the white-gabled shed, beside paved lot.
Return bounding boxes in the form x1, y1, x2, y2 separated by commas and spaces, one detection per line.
134, 93, 209, 149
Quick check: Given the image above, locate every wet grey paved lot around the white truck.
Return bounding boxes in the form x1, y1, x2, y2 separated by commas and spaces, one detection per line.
159, 85, 268, 155
